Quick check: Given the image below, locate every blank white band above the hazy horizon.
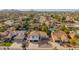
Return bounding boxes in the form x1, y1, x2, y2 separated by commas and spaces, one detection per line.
0, 0, 79, 9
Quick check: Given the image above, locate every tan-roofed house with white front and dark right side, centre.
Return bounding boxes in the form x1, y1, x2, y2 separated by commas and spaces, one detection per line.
28, 31, 48, 41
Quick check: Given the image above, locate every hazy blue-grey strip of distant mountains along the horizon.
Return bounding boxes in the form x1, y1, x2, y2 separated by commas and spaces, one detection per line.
0, 9, 79, 12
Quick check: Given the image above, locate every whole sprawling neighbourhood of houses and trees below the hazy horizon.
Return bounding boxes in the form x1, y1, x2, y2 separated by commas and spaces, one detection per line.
0, 9, 79, 50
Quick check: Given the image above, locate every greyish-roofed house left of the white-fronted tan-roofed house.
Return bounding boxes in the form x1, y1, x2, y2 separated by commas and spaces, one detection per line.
5, 31, 26, 42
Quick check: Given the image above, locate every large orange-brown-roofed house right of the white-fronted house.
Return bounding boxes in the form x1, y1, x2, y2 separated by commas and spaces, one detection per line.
51, 31, 67, 42
